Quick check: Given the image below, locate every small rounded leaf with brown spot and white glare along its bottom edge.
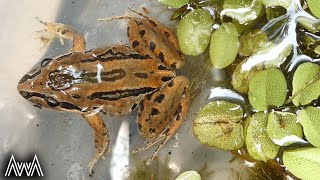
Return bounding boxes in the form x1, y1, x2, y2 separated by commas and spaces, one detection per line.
267, 112, 303, 146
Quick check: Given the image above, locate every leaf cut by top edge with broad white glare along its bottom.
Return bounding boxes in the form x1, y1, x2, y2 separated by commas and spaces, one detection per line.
221, 0, 263, 24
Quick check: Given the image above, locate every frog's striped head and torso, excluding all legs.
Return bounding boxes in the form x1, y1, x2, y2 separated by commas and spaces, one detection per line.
18, 45, 174, 116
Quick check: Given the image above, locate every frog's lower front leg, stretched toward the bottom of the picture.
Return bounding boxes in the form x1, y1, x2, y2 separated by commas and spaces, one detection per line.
83, 113, 109, 176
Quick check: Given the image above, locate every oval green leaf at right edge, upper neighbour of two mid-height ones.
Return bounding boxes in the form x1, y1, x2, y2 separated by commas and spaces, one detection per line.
292, 62, 320, 106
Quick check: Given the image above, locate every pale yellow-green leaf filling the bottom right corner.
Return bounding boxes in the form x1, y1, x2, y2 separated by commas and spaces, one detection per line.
282, 148, 320, 180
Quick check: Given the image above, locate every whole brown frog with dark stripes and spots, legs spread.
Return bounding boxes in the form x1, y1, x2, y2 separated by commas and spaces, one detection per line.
17, 8, 190, 175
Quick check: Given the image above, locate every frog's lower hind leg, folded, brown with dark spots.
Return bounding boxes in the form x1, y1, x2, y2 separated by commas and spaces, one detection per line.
131, 76, 190, 159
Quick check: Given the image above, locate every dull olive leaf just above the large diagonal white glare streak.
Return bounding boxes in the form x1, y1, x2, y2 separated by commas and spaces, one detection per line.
239, 29, 268, 56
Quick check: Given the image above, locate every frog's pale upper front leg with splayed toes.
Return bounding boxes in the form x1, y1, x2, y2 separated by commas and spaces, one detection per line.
36, 18, 86, 52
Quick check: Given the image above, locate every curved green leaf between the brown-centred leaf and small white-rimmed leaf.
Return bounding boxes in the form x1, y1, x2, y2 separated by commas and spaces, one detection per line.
245, 112, 280, 162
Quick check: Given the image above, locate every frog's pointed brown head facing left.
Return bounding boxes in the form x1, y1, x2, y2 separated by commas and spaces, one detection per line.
17, 58, 82, 110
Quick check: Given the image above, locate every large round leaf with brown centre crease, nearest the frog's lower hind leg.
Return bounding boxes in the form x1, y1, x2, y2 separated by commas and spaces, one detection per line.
193, 101, 244, 150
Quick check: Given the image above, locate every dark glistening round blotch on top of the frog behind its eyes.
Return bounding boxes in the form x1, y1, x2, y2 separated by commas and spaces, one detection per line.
48, 70, 75, 90
